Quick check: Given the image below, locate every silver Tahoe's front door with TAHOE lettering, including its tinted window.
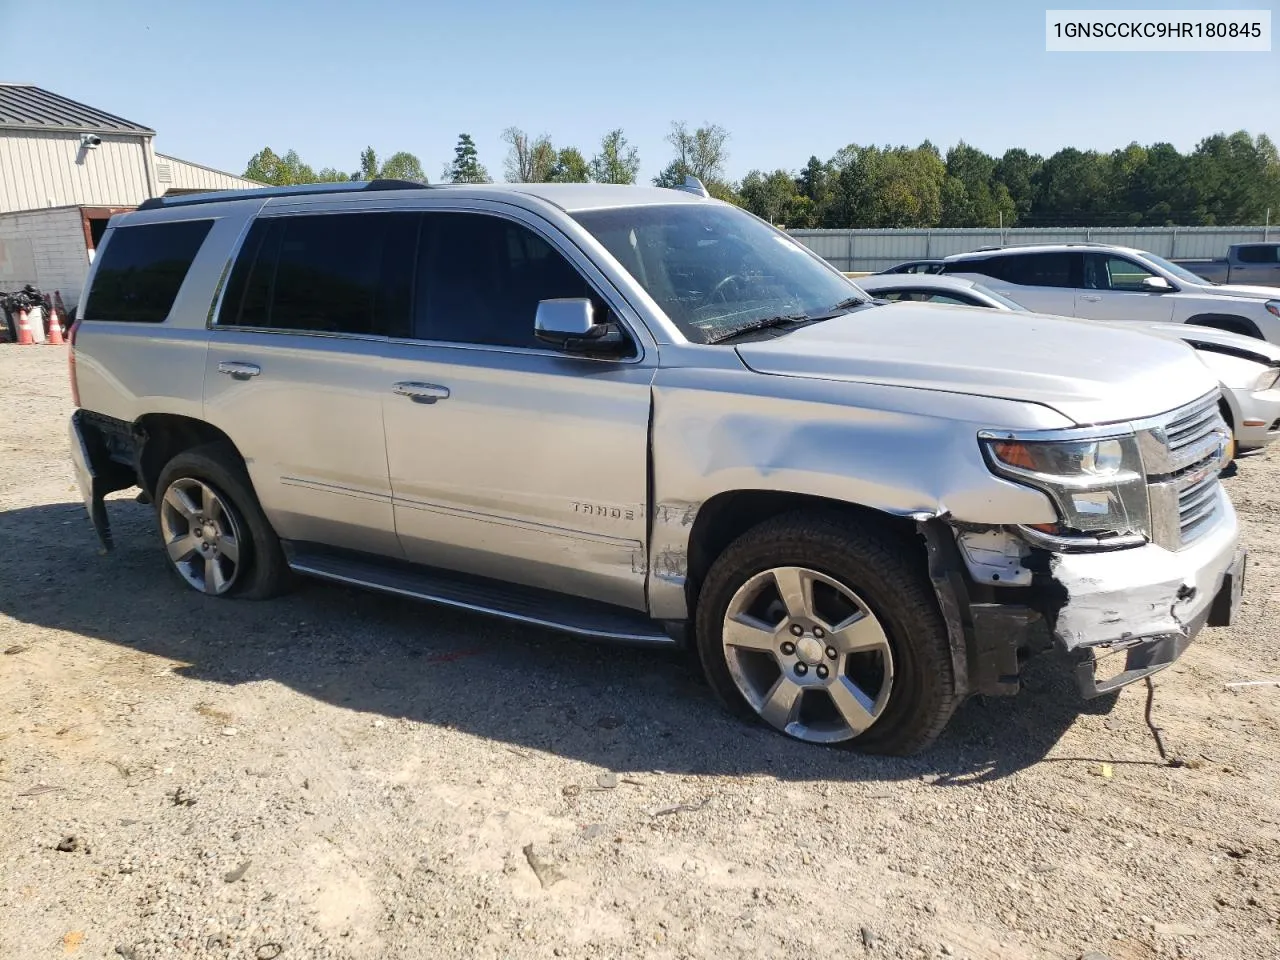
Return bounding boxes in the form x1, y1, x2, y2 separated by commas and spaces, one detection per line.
383, 211, 657, 609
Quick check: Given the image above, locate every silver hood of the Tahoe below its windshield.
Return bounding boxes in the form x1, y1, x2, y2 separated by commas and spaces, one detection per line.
737, 302, 1217, 425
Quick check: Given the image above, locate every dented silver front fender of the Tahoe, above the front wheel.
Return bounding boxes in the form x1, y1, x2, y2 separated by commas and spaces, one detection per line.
649, 344, 1073, 620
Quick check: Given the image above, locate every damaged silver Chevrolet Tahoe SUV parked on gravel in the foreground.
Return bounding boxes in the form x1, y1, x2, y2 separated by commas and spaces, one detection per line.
64, 182, 1244, 753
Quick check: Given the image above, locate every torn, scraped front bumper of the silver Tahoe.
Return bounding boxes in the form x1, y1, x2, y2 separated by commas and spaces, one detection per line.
1050, 494, 1247, 696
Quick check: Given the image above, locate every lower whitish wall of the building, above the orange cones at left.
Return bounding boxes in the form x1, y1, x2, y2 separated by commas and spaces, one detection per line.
0, 206, 88, 310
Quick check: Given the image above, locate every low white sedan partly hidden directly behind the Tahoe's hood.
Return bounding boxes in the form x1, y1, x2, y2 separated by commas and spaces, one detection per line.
858, 274, 1280, 463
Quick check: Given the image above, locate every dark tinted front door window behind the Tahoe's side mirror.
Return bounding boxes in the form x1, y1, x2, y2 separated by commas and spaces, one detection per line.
413, 214, 605, 349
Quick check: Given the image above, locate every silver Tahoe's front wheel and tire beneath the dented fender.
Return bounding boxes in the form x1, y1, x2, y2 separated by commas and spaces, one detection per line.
696, 512, 956, 755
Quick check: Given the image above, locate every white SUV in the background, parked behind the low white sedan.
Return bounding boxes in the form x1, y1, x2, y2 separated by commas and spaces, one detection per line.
942, 243, 1280, 344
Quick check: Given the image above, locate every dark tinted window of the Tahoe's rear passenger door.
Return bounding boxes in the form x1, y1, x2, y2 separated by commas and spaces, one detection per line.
219, 214, 421, 337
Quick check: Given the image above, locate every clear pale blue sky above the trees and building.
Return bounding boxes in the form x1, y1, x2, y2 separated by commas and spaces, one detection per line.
0, 0, 1280, 180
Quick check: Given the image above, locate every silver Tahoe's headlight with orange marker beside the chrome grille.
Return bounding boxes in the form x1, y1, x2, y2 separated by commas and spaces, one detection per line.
982, 434, 1151, 545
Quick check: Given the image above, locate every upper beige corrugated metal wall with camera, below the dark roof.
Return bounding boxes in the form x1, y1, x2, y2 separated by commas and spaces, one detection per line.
0, 131, 152, 212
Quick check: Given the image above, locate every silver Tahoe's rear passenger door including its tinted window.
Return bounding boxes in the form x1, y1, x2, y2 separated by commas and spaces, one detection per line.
205, 210, 420, 556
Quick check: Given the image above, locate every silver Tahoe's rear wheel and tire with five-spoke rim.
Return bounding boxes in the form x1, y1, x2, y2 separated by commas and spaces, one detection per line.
155, 443, 292, 600
